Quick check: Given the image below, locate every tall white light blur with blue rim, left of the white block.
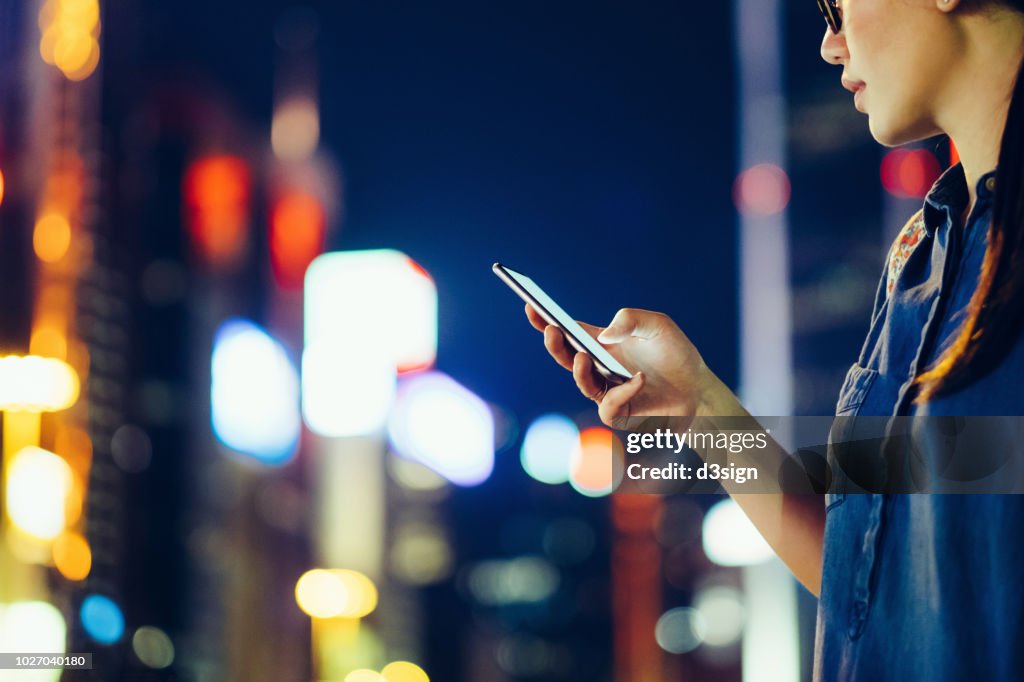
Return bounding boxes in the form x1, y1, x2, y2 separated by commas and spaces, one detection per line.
210, 318, 301, 465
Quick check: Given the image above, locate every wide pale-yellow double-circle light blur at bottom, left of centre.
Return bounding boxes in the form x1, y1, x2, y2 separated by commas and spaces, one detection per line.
295, 568, 377, 619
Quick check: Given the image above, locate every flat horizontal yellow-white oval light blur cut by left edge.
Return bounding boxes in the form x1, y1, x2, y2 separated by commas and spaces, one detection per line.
0, 355, 80, 412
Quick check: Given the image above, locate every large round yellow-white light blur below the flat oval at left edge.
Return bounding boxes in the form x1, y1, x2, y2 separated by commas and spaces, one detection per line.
4, 446, 72, 540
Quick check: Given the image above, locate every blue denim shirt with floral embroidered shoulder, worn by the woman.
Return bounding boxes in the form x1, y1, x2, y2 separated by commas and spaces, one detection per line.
814, 165, 1024, 682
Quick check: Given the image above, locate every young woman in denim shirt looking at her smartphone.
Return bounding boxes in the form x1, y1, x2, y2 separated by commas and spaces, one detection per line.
526, 0, 1024, 681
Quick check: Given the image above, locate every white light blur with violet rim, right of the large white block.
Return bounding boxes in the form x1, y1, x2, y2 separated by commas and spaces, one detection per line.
388, 372, 495, 485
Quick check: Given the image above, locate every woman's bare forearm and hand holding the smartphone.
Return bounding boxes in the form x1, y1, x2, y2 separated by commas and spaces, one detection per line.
526, 305, 825, 595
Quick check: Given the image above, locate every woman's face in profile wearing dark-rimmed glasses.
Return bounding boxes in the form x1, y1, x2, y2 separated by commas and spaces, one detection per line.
821, 0, 959, 146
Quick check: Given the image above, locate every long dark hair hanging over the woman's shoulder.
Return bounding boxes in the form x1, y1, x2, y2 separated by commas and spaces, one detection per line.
914, 0, 1024, 403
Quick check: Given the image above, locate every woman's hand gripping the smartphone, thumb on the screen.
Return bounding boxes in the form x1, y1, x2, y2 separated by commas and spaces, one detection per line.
526, 303, 718, 428
